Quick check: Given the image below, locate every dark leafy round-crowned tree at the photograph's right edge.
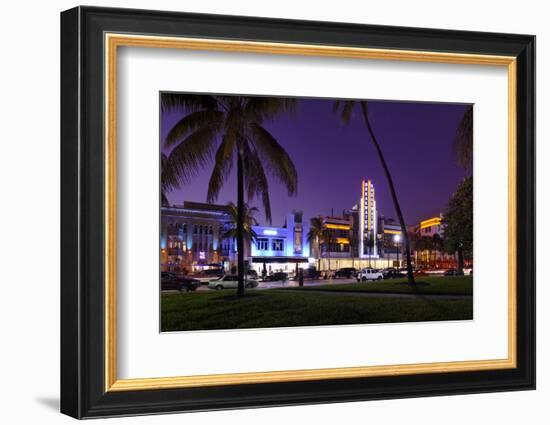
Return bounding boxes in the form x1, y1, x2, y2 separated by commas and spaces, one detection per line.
442, 177, 474, 270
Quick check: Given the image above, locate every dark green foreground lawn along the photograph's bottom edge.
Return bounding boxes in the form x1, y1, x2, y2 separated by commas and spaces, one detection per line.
161, 284, 473, 331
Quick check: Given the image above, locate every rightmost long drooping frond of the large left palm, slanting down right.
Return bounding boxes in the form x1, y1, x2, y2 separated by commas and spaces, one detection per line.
249, 123, 298, 196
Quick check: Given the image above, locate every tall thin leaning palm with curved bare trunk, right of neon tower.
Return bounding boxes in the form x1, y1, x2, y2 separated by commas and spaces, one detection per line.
333, 100, 414, 285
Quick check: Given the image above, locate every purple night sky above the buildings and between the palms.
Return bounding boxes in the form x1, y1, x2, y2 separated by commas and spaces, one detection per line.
161, 99, 467, 226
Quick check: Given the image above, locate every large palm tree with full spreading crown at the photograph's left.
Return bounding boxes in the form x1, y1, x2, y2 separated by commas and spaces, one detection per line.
161, 93, 298, 295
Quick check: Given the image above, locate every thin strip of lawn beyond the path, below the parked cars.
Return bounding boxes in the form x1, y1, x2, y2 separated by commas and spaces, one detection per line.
285, 276, 473, 295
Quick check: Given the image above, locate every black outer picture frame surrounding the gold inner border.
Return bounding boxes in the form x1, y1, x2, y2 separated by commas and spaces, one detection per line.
61, 7, 535, 418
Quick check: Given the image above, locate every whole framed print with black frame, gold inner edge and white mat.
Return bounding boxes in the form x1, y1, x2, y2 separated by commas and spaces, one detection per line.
61, 7, 535, 418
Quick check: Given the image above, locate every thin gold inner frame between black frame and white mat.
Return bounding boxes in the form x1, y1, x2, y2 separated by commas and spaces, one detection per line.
104, 33, 517, 391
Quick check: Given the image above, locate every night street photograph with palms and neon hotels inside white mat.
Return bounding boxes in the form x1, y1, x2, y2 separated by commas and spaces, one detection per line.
160, 92, 474, 332
